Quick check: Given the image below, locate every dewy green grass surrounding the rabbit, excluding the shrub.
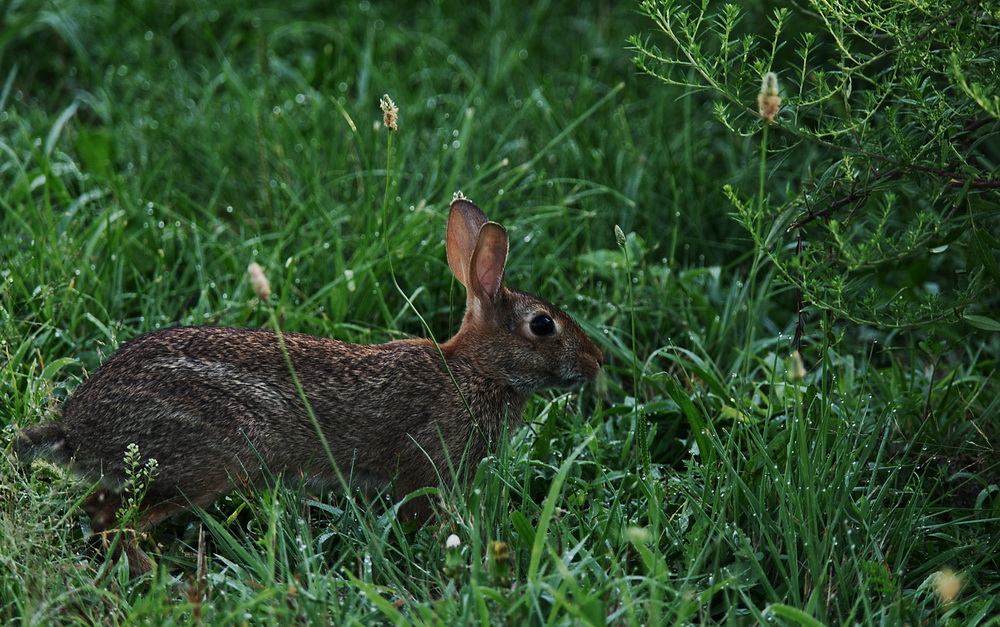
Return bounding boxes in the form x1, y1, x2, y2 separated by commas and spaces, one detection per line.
0, 0, 1000, 625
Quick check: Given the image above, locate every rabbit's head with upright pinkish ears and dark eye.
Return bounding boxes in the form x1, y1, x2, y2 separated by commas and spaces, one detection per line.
447, 198, 602, 394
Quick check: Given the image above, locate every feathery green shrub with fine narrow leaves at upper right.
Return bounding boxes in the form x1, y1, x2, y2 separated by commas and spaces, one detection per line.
631, 0, 1000, 331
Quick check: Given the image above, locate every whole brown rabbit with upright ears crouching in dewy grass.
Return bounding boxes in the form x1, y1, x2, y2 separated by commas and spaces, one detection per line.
15, 198, 601, 573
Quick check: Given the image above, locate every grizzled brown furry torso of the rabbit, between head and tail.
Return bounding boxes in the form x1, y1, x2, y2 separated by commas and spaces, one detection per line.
62, 327, 518, 498
